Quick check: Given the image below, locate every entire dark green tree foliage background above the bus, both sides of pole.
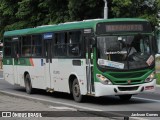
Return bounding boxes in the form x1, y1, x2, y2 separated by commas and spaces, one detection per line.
0, 0, 160, 38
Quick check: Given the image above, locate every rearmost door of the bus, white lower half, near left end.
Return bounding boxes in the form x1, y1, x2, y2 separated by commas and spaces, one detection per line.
11, 40, 20, 84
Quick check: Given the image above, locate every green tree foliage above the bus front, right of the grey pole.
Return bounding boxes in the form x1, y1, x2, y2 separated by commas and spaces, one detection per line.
111, 0, 159, 26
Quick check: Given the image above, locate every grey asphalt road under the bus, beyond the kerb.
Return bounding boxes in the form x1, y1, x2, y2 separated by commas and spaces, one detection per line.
0, 72, 160, 120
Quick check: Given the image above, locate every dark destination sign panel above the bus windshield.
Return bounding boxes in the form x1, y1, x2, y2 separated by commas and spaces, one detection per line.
96, 21, 152, 34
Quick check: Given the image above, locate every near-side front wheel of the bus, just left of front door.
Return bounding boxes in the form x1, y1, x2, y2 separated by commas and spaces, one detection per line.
72, 78, 83, 102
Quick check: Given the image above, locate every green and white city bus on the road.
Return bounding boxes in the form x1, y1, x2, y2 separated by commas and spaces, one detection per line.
3, 18, 156, 102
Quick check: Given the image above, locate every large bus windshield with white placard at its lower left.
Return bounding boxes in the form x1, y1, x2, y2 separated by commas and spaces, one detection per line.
97, 34, 154, 70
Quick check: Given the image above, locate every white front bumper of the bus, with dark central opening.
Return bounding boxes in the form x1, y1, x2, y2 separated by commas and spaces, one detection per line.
95, 79, 156, 96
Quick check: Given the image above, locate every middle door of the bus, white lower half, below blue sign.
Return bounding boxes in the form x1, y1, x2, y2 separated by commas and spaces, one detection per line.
44, 39, 53, 89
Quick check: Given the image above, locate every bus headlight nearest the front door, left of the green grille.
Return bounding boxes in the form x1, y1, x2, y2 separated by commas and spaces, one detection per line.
96, 74, 112, 85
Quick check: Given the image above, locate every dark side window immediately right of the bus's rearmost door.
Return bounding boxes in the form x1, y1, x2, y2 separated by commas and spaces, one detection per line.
22, 36, 31, 57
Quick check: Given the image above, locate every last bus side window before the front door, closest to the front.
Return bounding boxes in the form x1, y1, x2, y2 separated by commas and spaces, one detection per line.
68, 31, 82, 56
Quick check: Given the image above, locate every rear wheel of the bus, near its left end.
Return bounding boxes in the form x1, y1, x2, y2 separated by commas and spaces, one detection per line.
24, 74, 33, 94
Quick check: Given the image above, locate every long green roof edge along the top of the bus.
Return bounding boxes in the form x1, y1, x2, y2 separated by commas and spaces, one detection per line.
4, 18, 147, 37
